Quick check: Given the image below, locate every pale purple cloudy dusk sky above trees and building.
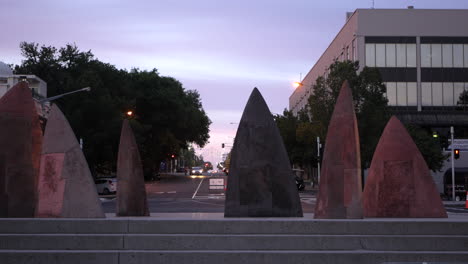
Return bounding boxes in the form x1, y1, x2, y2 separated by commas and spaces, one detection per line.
0, 0, 468, 163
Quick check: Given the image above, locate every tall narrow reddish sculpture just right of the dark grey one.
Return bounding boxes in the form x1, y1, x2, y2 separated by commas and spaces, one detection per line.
314, 81, 362, 219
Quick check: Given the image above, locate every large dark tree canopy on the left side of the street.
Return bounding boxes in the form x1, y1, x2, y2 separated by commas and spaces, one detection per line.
14, 42, 211, 177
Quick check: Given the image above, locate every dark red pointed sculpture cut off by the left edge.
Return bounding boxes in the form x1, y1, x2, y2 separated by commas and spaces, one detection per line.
0, 82, 42, 217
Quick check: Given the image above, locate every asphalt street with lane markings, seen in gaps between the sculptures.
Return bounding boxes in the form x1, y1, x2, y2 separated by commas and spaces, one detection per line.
101, 173, 468, 216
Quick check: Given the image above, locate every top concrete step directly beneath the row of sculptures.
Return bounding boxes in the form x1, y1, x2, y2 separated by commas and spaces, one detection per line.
0, 218, 468, 235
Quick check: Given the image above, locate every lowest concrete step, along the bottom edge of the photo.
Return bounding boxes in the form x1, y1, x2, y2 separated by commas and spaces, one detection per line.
0, 250, 468, 264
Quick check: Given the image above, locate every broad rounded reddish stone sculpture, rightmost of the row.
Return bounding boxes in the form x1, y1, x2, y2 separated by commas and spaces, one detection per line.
363, 116, 447, 218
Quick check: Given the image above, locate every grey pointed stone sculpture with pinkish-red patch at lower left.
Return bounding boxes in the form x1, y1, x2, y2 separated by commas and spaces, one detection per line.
36, 105, 105, 218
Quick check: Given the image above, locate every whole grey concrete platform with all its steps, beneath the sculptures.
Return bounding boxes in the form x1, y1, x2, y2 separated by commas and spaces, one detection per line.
0, 213, 468, 264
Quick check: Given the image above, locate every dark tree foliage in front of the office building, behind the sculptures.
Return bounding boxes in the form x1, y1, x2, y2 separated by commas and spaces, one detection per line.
275, 61, 446, 175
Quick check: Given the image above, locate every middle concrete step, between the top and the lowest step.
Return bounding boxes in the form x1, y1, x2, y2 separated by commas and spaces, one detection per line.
0, 234, 468, 251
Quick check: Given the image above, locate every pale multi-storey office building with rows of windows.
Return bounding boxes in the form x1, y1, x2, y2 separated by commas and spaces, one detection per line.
289, 7, 468, 194
